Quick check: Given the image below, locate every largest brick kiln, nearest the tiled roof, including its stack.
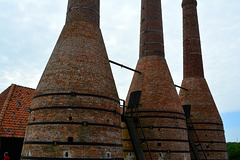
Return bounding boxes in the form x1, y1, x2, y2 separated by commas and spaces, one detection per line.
22, 0, 123, 160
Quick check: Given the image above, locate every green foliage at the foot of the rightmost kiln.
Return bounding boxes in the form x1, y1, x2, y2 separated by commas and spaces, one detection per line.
227, 142, 240, 160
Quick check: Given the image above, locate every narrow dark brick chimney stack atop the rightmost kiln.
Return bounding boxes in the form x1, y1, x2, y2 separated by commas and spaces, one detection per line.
183, 0, 204, 78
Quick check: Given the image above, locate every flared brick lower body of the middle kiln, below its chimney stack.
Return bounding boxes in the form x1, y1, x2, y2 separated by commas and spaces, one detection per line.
123, 55, 190, 159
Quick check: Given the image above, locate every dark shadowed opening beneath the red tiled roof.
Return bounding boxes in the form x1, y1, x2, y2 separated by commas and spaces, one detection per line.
0, 138, 23, 160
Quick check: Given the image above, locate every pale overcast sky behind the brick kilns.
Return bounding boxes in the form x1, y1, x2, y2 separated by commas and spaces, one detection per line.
0, 0, 240, 141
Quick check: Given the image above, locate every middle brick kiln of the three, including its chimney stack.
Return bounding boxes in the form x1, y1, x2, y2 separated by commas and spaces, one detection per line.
123, 0, 190, 160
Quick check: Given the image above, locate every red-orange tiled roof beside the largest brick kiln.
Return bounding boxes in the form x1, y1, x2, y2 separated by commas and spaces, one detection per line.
0, 84, 35, 138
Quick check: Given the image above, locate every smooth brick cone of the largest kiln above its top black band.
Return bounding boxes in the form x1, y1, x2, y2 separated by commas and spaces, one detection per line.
35, 21, 118, 99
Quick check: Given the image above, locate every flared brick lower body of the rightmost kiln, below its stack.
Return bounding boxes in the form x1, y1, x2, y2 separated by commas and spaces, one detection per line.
180, 77, 228, 159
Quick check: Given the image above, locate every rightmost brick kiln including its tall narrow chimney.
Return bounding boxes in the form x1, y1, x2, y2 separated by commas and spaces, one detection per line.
180, 0, 228, 160
